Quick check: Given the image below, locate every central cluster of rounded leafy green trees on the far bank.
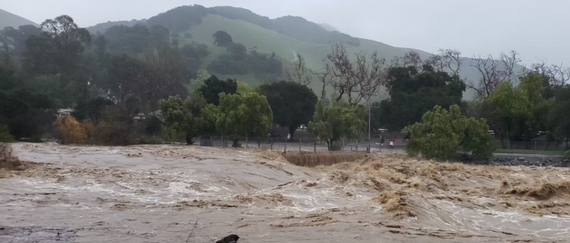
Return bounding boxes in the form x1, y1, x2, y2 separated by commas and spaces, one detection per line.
160, 76, 366, 150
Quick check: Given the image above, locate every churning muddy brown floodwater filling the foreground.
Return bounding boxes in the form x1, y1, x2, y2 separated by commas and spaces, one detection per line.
0, 143, 570, 243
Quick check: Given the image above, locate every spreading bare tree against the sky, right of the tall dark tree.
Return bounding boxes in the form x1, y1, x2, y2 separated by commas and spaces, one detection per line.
467, 51, 521, 97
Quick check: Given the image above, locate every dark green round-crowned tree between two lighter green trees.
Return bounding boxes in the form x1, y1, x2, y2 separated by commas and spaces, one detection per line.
258, 81, 318, 138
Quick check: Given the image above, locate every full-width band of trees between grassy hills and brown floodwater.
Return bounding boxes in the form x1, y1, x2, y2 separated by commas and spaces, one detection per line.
0, 16, 570, 156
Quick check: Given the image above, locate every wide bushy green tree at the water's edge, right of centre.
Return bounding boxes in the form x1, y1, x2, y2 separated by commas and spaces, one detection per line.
406, 105, 493, 160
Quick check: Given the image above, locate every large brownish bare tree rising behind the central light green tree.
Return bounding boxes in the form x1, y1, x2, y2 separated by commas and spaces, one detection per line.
327, 44, 386, 105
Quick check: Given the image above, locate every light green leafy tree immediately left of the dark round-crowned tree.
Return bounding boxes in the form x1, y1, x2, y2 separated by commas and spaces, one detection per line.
216, 92, 273, 147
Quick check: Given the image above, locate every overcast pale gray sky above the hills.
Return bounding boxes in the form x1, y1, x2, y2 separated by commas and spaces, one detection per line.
0, 0, 570, 65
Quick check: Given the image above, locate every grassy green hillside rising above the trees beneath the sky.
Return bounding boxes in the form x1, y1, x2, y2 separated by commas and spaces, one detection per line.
88, 5, 516, 98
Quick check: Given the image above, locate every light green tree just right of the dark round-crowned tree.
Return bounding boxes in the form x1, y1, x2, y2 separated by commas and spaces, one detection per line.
308, 101, 366, 151
